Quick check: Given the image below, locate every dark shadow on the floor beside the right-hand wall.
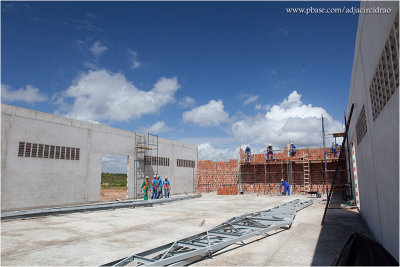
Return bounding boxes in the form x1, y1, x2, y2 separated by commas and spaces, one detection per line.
312, 200, 374, 266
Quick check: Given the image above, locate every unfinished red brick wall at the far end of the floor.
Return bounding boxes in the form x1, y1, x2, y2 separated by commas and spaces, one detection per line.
198, 148, 351, 194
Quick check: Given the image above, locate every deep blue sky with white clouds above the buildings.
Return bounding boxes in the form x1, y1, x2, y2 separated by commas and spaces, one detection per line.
1, 1, 359, 172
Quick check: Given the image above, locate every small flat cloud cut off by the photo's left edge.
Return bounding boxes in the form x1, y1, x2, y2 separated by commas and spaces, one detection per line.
1, 84, 47, 103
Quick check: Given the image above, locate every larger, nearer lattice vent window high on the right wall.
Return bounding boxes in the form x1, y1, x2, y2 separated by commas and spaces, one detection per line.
370, 15, 399, 120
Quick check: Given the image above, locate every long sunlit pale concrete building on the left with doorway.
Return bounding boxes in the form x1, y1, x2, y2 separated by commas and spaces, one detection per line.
1, 104, 197, 211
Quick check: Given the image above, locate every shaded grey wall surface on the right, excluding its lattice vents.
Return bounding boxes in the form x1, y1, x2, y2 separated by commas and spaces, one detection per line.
347, 2, 399, 260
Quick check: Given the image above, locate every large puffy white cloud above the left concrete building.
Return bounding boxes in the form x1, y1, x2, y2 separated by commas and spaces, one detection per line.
56, 69, 180, 121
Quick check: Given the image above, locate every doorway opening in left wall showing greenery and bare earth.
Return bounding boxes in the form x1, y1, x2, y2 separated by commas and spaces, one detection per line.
100, 154, 129, 201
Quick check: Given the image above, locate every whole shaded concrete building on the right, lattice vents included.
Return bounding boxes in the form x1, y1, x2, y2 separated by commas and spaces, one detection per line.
347, 1, 399, 260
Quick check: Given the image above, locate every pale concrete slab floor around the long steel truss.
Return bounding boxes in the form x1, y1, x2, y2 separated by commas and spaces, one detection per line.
1, 194, 370, 266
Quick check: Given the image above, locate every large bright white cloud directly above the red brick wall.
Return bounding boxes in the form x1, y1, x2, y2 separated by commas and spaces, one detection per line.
232, 91, 342, 147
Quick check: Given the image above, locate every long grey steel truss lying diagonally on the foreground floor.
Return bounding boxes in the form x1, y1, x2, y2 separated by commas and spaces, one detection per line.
104, 199, 313, 266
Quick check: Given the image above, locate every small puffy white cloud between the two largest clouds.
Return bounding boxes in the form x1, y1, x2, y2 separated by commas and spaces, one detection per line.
182, 99, 229, 127
